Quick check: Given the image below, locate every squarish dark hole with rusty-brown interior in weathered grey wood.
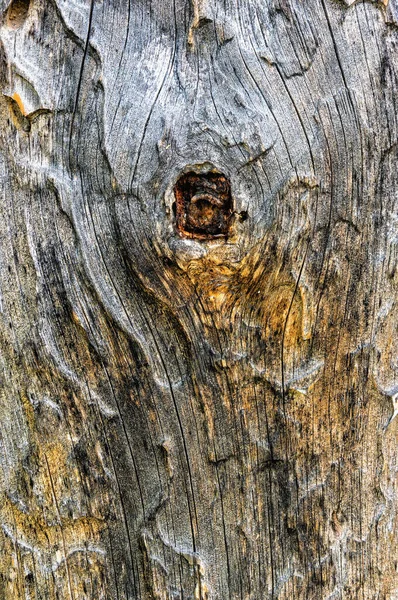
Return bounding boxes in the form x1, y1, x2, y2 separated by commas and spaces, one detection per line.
174, 173, 233, 239
